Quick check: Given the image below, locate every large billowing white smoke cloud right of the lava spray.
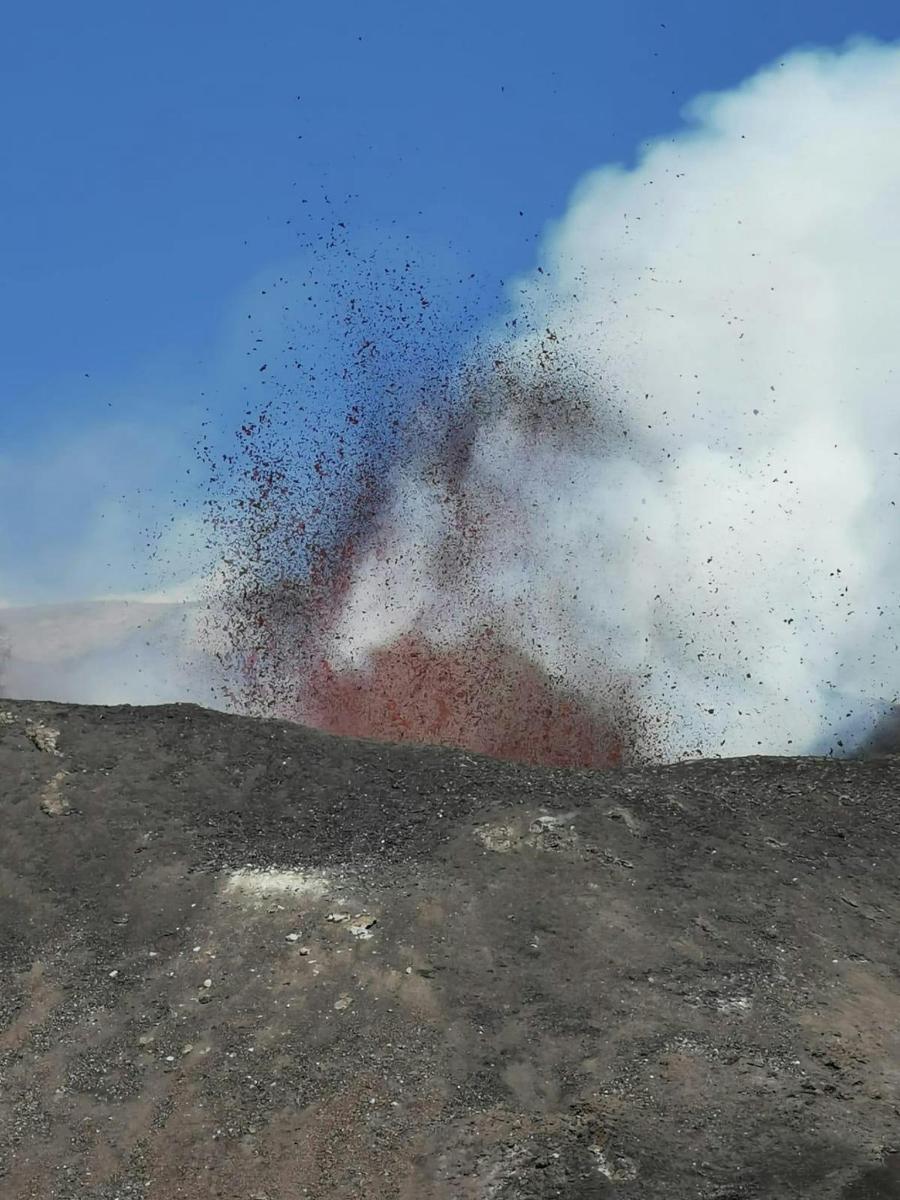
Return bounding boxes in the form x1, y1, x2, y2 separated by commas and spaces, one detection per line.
324, 43, 900, 757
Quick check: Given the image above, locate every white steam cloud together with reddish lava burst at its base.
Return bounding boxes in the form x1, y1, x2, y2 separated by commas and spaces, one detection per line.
207, 44, 900, 762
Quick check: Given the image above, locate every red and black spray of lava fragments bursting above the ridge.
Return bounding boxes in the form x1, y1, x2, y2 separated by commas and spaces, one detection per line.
204, 309, 638, 766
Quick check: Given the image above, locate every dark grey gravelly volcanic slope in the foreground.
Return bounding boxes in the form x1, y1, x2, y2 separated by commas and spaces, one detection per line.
0, 701, 900, 1200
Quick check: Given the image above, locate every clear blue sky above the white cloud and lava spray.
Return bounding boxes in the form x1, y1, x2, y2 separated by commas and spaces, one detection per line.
0, 0, 900, 599
